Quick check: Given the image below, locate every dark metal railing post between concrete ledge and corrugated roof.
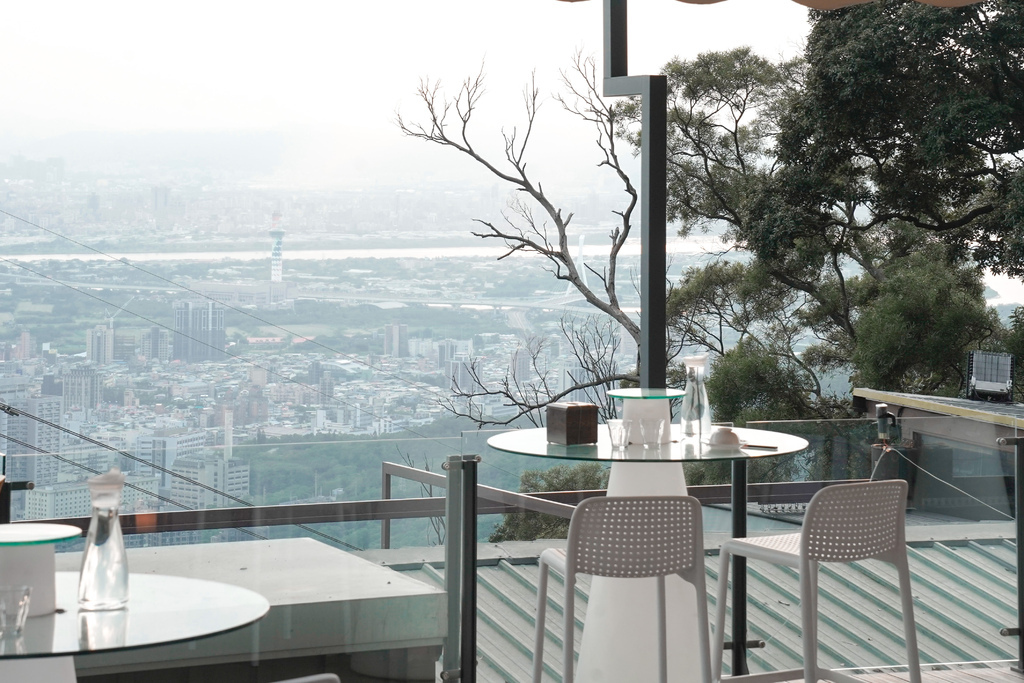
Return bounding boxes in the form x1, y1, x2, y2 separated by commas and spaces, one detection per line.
440, 456, 480, 683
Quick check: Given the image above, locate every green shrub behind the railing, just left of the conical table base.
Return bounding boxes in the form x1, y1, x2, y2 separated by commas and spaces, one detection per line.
488, 463, 608, 543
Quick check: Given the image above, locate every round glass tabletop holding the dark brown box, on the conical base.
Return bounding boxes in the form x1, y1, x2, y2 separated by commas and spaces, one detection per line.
487, 425, 808, 463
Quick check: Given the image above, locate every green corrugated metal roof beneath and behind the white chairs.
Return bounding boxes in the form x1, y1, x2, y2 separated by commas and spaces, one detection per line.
373, 517, 1017, 683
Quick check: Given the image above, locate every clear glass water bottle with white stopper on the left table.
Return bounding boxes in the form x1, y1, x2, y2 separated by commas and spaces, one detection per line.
78, 467, 128, 611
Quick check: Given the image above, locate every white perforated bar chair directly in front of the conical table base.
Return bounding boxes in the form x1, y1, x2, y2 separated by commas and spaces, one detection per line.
534, 496, 711, 683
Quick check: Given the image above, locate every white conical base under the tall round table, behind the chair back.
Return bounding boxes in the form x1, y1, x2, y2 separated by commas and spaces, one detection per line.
575, 458, 707, 683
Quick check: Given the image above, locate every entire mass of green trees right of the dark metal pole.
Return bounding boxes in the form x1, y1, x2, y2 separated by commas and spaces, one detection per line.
643, 5, 1024, 421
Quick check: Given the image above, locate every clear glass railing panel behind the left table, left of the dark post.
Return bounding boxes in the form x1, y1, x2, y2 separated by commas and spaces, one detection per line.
0, 436, 452, 683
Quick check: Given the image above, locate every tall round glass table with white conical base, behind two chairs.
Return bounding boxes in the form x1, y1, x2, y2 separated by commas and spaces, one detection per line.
487, 423, 808, 683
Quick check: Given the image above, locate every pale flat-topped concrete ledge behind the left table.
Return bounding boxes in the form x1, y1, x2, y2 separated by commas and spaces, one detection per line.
57, 539, 447, 676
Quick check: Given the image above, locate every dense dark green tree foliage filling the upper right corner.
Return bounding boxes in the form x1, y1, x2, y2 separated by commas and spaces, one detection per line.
778, 0, 1024, 273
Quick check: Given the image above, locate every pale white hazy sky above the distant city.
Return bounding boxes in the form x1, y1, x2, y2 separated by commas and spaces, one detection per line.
0, 0, 807, 184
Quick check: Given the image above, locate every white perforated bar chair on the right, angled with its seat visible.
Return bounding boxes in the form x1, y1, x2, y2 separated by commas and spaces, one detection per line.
713, 479, 921, 683
